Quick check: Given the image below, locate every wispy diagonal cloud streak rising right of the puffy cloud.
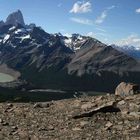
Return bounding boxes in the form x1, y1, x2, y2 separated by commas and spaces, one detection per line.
95, 5, 116, 24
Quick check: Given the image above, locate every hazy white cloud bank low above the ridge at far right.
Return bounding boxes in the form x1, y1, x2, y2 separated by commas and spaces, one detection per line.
115, 34, 140, 48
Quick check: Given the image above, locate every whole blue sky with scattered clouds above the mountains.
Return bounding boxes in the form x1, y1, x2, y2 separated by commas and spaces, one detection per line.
0, 0, 140, 47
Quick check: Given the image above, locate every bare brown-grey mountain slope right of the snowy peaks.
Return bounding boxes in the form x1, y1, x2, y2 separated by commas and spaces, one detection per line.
68, 39, 137, 75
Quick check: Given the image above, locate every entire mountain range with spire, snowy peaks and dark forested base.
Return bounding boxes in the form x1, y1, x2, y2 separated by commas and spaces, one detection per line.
0, 10, 140, 92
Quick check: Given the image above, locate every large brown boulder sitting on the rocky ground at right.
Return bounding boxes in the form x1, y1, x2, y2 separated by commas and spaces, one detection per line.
115, 82, 139, 97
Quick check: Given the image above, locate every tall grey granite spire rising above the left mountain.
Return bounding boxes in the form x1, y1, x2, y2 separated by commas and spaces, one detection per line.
6, 10, 25, 26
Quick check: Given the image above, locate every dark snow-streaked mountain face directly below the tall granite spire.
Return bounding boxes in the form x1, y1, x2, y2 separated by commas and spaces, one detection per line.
0, 27, 73, 71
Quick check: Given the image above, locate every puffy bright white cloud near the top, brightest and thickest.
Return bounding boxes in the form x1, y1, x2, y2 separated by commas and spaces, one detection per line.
70, 1, 92, 14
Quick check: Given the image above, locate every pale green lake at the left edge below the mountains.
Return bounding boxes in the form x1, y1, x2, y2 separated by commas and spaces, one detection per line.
0, 73, 14, 83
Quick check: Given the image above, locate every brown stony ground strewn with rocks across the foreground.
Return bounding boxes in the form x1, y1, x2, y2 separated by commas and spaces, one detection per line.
0, 92, 140, 140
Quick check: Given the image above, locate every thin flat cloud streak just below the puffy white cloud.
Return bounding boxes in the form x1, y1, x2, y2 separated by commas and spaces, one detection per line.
70, 17, 93, 25
